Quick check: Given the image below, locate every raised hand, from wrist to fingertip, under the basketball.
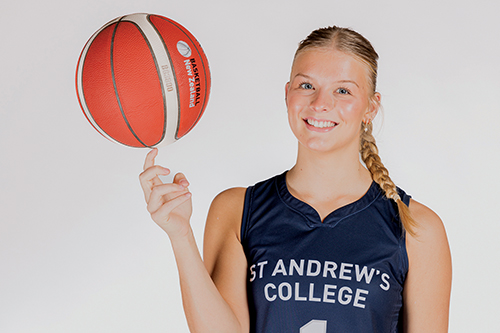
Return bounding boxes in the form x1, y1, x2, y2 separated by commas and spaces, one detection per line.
139, 148, 192, 240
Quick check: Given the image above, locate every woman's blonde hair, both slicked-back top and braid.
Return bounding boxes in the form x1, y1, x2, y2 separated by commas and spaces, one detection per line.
295, 26, 416, 236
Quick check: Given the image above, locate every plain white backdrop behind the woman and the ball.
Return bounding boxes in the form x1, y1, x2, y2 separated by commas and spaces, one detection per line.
0, 0, 500, 333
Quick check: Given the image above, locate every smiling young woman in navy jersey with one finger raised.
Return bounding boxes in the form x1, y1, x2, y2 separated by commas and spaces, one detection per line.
140, 27, 451, 333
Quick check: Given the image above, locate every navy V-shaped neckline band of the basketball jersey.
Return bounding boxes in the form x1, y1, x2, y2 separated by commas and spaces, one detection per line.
276, 171, 382, 227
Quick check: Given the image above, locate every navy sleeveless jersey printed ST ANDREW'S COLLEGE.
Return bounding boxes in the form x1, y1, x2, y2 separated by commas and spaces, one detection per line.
241, 172, 410, 333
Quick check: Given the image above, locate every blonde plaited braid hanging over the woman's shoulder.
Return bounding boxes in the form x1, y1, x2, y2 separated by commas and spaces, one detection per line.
359, 123, 416, 236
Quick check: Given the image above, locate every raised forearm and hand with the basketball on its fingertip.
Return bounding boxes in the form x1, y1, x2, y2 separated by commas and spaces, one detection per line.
140, 149, 248, 333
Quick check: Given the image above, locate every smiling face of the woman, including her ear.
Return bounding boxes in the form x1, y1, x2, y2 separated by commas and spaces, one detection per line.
286, 48, 380, 153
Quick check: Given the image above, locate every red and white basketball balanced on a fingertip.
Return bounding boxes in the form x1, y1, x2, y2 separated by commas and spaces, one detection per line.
76, 14, 211, 148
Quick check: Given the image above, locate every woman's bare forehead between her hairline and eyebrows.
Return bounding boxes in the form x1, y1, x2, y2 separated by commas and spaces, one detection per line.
291, 48, 370, 84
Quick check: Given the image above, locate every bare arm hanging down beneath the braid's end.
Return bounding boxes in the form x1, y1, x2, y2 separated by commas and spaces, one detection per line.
403, 200, 452, 333
